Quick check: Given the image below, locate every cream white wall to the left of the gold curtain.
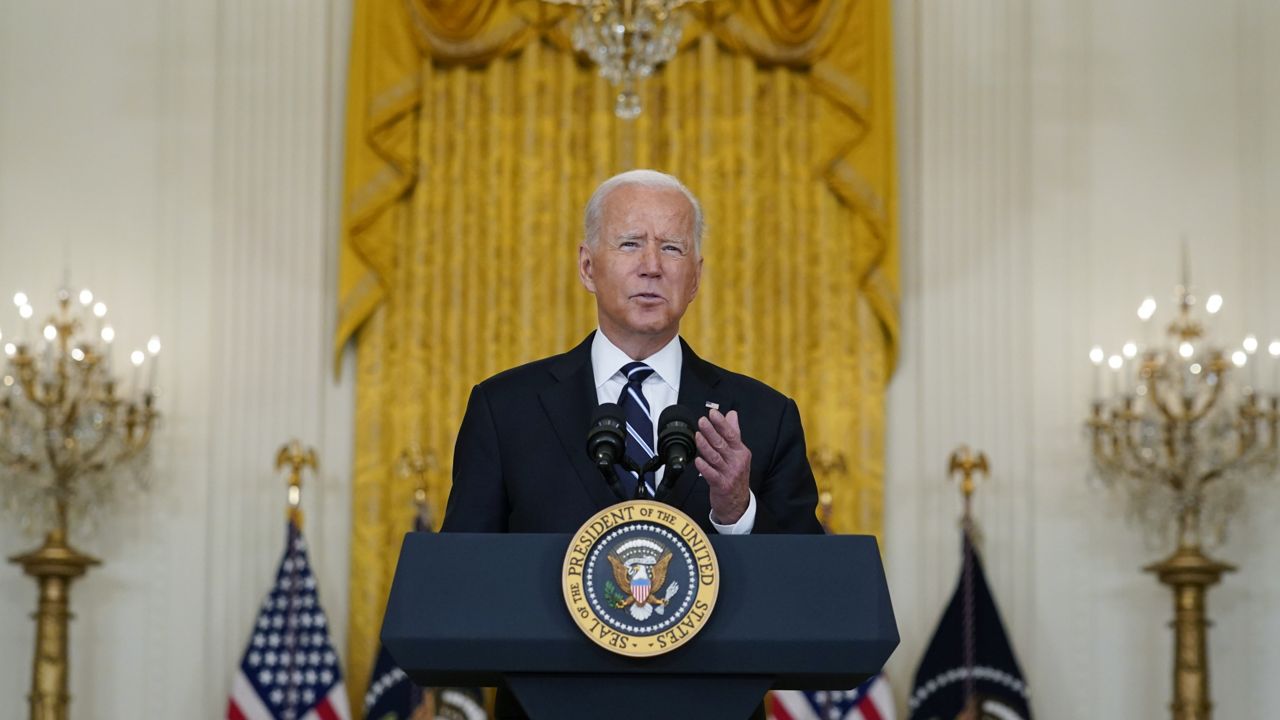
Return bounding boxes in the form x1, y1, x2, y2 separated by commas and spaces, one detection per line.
0, 0, 352, 720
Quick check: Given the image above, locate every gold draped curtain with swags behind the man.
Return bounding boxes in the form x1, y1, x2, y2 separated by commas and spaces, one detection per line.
335, 0, 897, 706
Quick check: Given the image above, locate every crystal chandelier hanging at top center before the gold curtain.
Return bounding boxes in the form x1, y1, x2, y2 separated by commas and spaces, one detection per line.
545, 0, 701, 120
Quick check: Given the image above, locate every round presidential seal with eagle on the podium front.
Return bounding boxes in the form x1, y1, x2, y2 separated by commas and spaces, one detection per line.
562, 500, 719, 657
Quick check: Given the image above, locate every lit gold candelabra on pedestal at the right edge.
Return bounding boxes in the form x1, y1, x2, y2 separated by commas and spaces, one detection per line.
1087, 262, 1280, 720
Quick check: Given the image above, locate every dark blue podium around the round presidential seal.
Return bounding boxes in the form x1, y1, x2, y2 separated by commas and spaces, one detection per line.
381, 533, 899, 720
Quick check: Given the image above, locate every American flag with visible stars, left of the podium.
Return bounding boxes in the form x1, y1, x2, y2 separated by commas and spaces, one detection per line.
227, 520, 351, 720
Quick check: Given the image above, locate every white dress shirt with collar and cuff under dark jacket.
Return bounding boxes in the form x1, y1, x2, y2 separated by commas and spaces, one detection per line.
591, 329, 755, 536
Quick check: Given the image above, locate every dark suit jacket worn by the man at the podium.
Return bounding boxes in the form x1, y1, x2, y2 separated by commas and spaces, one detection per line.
443, 336, 822, 533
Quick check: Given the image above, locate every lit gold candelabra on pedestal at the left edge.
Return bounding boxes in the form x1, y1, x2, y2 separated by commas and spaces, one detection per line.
0, 287, 160, 720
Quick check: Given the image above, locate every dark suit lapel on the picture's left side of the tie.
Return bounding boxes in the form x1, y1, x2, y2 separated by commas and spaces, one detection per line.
538, 333, 618, 509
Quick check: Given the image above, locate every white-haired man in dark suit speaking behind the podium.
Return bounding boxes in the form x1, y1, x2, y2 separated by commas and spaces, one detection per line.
443, 170, 822, 717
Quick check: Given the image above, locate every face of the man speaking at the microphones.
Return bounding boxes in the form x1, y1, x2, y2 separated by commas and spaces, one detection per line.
577, 184, 703, 351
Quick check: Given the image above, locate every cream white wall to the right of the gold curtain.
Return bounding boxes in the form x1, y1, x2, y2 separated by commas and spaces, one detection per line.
886, 0, 1280, 720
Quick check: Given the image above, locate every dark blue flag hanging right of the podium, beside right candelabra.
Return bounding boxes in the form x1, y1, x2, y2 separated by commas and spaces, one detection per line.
908, 527, 1032, 720
